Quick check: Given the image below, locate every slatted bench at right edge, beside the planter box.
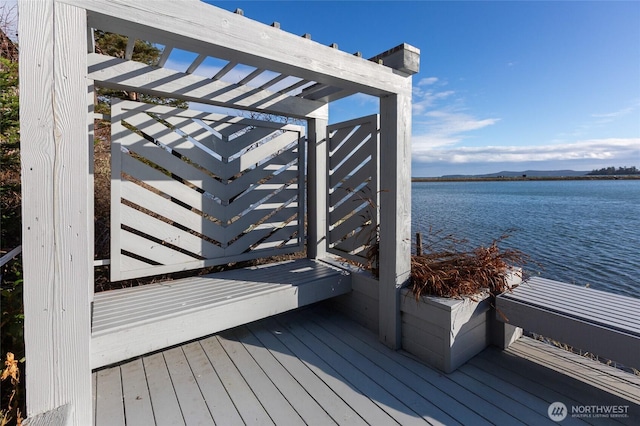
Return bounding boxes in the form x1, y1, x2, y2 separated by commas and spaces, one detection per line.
496, 277, 640, 368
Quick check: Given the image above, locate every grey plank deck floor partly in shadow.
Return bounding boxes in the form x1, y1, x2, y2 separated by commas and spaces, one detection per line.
93, 305, 640, 426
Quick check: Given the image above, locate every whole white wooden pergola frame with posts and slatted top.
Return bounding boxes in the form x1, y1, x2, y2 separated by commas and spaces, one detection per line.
19, 0, 419, 425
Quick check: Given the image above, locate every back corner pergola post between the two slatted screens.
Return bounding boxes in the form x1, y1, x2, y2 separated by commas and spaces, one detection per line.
307, 113, 328, 259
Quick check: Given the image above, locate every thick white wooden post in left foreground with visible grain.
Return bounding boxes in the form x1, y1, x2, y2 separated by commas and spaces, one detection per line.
19, 0, 93, 425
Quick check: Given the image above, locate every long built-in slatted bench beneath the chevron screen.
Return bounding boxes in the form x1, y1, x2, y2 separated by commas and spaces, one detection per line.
91, 259, 351, 369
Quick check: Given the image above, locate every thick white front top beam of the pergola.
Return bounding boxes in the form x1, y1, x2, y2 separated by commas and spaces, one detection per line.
60, 0, 411, 96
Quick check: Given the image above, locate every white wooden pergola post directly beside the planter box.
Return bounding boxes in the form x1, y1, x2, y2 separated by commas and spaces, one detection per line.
379, 91, 411, 349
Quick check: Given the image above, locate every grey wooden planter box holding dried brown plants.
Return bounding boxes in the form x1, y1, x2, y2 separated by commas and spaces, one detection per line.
400, 272, 521, 373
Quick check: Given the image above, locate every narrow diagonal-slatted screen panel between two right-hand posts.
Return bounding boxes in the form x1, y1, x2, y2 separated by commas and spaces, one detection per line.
327, 115, 380, 262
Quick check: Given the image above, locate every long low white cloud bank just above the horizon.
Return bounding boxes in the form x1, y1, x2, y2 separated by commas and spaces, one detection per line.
413, 137, 640, 164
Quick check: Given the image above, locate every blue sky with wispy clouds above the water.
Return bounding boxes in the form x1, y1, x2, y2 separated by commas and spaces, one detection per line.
208, 0, 640, 176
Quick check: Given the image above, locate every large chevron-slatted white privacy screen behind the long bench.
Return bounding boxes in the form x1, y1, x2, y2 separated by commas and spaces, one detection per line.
111, 100, 305, 281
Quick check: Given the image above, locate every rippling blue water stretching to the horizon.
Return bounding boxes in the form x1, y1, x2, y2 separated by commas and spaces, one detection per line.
412, 180, 640, 298
